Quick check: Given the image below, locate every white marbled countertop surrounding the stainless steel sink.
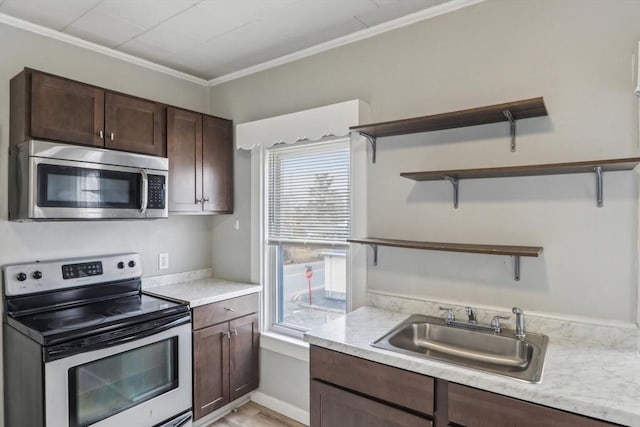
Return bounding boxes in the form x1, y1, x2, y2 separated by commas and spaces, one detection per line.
305, 307, 640, 427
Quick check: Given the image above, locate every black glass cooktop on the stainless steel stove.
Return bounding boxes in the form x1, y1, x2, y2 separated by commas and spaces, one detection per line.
10, 294, 189, 345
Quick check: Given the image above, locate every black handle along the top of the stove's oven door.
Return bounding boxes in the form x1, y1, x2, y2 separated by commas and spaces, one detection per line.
44, 313, 191, 362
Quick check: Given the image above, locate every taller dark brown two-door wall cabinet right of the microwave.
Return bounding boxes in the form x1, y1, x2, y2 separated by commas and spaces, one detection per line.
167, 107, 233, 214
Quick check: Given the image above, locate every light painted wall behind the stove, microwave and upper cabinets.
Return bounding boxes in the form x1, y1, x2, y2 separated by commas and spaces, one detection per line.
0, 24, 212, 426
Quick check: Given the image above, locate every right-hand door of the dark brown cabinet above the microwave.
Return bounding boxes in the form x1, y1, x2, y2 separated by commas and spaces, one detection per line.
105, 92, 167, 156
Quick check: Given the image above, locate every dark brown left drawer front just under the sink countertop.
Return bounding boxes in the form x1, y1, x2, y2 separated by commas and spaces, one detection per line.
310, 346, 434, 415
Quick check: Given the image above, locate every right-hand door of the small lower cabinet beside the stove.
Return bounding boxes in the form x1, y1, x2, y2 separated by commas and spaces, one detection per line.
229, 314, 259, 400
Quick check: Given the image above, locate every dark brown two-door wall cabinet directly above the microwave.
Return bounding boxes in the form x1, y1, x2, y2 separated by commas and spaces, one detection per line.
10, 68, 166, 157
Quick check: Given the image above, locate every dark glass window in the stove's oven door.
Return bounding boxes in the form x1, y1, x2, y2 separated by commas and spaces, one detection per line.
69, 337, 178, 427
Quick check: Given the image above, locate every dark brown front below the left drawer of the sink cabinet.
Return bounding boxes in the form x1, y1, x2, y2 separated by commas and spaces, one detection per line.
310, 380, 432, 427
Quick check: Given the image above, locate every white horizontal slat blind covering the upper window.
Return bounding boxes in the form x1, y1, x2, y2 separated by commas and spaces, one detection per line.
267, 139, 351, 244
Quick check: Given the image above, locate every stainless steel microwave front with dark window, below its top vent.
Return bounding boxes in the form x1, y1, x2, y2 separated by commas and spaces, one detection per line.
29, 157, 167, 219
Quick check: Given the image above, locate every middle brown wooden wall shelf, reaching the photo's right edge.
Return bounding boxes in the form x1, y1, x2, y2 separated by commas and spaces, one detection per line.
400, 157, 640, 181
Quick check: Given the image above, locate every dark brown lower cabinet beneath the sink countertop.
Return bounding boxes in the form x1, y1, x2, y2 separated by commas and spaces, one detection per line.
310, 345, 616, 427
